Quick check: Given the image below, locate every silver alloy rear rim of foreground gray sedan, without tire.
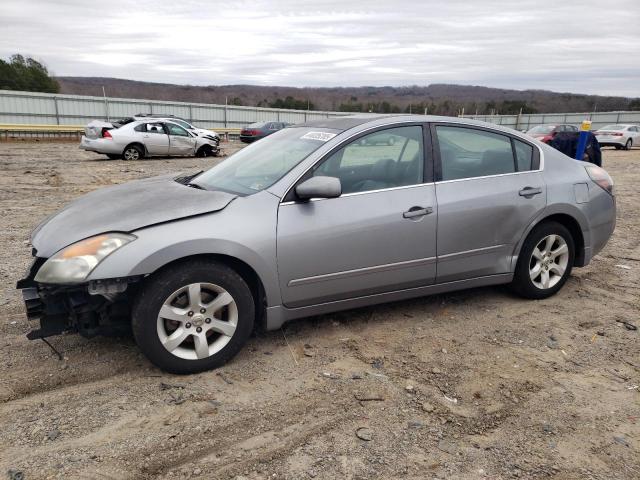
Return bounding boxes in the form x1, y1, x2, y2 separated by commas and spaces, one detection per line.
529, 235, 569, 290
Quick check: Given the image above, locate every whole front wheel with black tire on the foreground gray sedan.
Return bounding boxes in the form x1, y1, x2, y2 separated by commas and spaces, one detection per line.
131, 260, 255, 374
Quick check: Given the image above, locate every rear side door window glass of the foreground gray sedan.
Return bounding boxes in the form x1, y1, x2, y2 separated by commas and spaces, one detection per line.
436, 126, 516, 180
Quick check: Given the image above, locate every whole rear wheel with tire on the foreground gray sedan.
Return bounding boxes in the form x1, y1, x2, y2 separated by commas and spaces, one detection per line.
511, 222, 575, 299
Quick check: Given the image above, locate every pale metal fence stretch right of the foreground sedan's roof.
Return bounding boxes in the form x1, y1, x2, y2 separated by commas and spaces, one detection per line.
464, 112, 640, 130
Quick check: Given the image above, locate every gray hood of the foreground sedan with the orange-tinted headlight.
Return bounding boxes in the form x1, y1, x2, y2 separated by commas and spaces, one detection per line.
31, 174, 236, 257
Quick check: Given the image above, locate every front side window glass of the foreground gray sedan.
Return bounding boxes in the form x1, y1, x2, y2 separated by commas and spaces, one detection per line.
313, 125, 424, 194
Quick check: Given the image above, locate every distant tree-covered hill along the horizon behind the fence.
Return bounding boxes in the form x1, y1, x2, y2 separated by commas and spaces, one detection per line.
56, 77, 640, 115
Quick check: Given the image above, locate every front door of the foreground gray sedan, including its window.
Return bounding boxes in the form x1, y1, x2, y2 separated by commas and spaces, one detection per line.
277, 125, 437, 307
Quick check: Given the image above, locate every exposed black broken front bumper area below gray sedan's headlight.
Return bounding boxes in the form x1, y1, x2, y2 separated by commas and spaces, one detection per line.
16, 257, 141, 340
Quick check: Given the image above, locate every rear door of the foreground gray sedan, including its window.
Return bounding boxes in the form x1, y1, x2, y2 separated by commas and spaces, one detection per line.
432, 123, 546, 283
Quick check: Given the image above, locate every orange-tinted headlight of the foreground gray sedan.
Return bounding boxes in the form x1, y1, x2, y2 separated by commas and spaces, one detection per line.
35, 233, 137, 283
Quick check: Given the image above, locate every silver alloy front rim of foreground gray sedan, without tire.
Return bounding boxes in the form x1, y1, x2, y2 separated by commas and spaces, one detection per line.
157, 283, 238, 360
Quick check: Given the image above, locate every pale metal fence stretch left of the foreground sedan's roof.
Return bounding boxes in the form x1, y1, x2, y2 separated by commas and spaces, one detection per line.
0, 90, 345, 128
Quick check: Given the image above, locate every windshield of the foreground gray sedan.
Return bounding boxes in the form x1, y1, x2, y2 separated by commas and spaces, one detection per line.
191, 127, 339, 195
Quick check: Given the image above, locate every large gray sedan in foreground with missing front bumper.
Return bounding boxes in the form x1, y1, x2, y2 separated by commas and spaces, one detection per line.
18, 115, 616, 373
